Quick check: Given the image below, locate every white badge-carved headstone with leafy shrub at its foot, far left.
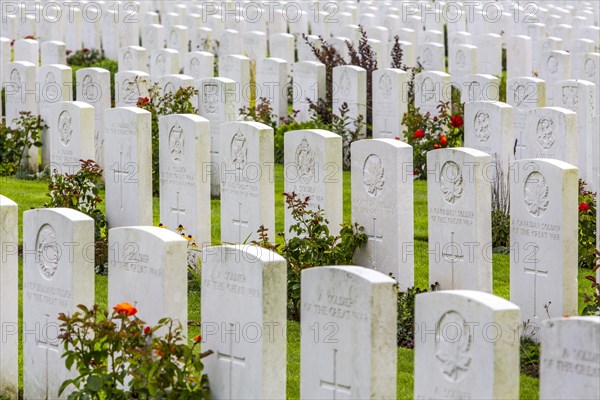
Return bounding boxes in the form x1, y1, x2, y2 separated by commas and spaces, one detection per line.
47, 101, 95, 174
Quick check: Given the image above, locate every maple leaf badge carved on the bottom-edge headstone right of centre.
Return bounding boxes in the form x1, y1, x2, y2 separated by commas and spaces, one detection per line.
435, 311, 473, 382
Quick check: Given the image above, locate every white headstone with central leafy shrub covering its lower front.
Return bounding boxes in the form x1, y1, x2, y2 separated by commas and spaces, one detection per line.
284, 129, 343, 236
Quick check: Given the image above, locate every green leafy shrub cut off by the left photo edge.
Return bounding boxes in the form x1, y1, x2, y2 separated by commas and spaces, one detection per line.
0, 111, 46, 176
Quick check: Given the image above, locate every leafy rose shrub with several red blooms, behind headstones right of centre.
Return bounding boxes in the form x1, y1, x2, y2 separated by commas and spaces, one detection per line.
402, 102, 464, 179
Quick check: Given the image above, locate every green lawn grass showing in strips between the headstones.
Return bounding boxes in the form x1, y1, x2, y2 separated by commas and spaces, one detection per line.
0, 165, 590, 399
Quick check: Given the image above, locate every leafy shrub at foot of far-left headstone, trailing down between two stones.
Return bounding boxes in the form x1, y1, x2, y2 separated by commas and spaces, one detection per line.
44, 160, 108, 275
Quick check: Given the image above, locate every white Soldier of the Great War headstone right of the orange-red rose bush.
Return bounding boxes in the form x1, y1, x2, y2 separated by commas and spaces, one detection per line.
201, 245, 287, 399
